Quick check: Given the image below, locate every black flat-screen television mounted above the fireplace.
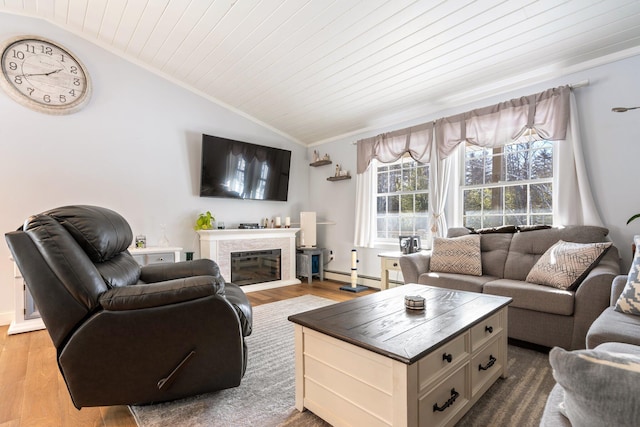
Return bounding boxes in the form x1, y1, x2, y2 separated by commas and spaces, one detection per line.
200, 135, 291, 202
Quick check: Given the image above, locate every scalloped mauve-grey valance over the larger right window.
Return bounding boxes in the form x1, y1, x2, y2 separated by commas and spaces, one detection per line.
435, 86, 571, 159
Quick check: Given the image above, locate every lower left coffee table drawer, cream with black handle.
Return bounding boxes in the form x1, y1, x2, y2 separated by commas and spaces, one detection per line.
418, 363, 471, 427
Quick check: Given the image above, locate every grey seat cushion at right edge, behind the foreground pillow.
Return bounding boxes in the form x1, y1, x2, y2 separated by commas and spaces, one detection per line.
587, 307, 640, 348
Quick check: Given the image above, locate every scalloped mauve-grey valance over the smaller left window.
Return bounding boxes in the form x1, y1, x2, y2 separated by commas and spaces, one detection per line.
357, 122, 434, 174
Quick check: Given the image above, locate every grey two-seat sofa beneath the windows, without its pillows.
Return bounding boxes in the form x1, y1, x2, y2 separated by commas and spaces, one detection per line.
399, 226, 620, 350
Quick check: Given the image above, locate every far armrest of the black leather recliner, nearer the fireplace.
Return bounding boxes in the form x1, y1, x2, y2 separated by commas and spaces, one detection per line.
140, 258, 224, 283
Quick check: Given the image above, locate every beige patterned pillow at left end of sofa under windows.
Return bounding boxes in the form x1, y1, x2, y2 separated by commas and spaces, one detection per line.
429, 234, 482, 276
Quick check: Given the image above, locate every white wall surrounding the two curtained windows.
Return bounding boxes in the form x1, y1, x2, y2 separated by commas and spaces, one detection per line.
309, 52, 640, 279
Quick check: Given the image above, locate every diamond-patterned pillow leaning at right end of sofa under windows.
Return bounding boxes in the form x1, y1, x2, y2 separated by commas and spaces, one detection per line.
527, 240, 613, 291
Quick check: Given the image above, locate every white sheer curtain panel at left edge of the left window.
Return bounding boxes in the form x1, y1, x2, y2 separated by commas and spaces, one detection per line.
353, 160, 376, 248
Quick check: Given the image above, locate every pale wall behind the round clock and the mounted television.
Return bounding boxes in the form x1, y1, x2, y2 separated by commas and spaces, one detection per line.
0, 13, 309, 324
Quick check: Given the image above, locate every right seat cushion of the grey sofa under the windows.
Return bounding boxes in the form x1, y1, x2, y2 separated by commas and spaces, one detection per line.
483, 279, 575, 316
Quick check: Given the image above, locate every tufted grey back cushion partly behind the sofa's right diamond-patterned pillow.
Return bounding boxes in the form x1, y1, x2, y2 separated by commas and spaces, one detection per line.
503, 225, 609, 280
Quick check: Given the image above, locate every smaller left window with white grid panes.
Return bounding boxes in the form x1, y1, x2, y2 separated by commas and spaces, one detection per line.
376, 155, 429, 243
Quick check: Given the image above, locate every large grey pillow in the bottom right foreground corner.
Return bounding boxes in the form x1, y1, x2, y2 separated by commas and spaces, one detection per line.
549, 347, 640, 427
